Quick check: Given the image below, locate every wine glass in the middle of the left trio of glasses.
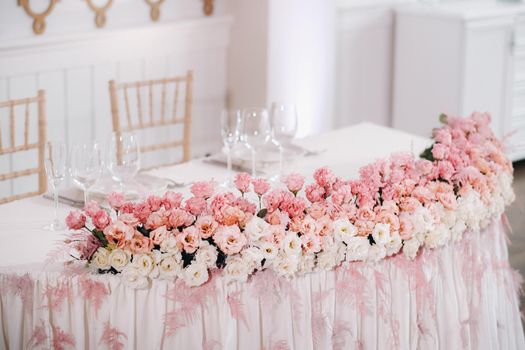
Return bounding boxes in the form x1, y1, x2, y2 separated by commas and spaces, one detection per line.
69, 143, 102, 205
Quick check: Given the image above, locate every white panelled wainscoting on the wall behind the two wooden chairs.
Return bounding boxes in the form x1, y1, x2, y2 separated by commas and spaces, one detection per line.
0, 16, 232, 197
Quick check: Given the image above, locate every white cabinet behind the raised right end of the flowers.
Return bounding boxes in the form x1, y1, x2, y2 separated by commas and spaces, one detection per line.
392, 1, 525, 160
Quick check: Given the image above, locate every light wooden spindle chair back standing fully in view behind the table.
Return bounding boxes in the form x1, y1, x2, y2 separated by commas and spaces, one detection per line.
109, 70, 193, 169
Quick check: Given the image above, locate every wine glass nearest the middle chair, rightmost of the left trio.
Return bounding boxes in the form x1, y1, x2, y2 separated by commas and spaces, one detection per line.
108, 132, 140, 193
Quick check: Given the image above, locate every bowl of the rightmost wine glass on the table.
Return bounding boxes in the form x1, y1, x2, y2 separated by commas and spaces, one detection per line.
271, 102, 297, 146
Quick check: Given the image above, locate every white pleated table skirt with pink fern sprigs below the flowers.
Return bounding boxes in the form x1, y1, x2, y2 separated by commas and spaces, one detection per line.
0, 222, 525, 350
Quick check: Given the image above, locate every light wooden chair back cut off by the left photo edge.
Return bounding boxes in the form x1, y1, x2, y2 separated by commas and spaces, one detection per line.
0, 90, 47, 204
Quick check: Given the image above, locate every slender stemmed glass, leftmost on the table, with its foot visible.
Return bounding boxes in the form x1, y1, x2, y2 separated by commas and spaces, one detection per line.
44, 141, 66, 231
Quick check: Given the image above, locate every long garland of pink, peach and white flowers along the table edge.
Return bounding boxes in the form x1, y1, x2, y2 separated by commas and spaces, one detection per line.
62, 113, 514, 288
